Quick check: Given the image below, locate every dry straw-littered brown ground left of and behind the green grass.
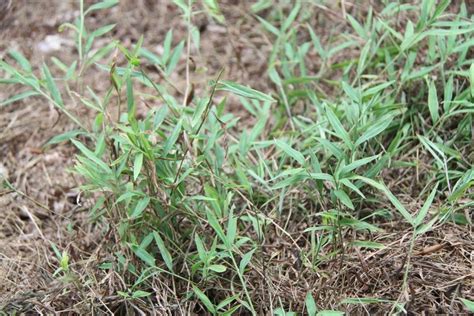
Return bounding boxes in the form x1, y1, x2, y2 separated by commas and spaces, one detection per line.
0, 0, 274, 313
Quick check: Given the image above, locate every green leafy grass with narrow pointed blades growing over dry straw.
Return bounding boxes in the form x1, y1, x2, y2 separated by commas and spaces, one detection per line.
0, 0, 474, 315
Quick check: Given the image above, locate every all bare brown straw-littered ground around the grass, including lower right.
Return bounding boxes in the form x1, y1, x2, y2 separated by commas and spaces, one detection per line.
0, 0, 474, 314
